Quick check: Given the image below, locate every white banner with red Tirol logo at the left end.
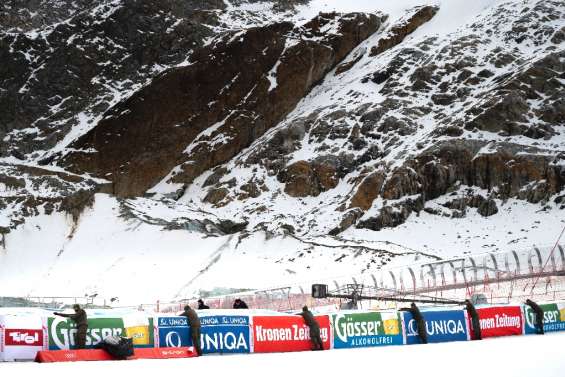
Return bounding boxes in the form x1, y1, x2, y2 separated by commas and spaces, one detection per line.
0, 315, 44, 361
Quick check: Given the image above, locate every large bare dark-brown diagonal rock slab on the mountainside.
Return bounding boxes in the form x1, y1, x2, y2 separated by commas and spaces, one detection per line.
62, 13, 381, 196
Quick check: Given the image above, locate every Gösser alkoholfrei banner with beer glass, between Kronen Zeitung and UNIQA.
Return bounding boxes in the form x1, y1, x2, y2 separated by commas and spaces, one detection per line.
332, 312, 404, 348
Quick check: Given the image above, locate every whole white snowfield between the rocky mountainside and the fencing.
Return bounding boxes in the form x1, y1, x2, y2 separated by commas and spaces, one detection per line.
0, 194, 565, 305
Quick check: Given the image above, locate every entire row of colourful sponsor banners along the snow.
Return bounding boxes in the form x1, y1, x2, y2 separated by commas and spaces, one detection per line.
0, 302, 565, 361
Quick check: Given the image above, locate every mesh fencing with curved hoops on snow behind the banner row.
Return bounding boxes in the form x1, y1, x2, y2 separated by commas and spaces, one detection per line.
4, 245, 565, 313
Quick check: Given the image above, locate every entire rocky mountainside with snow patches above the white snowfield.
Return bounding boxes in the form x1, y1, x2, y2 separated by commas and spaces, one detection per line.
0, 0, 565, 241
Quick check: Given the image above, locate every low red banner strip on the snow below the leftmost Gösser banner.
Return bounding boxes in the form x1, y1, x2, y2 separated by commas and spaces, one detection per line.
35, 347, 196, 363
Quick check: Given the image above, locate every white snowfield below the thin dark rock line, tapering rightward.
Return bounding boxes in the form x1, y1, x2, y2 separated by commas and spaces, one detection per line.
0, 195, 437, 304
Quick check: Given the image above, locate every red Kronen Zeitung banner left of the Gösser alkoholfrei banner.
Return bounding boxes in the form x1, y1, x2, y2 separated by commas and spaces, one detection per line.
253, 315, 330, 353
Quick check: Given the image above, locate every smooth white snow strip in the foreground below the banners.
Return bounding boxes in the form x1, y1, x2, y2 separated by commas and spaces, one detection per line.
4, 333, 565, 377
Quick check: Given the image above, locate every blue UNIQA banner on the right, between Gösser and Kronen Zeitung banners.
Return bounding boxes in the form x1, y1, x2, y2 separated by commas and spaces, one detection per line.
402, 310, 469, 344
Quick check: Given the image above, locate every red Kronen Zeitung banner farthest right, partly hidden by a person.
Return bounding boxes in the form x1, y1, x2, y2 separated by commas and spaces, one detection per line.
477, 306, 524, 338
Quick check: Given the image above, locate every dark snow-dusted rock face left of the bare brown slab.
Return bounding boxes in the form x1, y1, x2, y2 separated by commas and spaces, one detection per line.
0, 0, 326, 233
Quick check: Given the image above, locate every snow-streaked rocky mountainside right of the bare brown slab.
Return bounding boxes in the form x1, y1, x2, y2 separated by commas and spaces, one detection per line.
173, 1, 565, 233
